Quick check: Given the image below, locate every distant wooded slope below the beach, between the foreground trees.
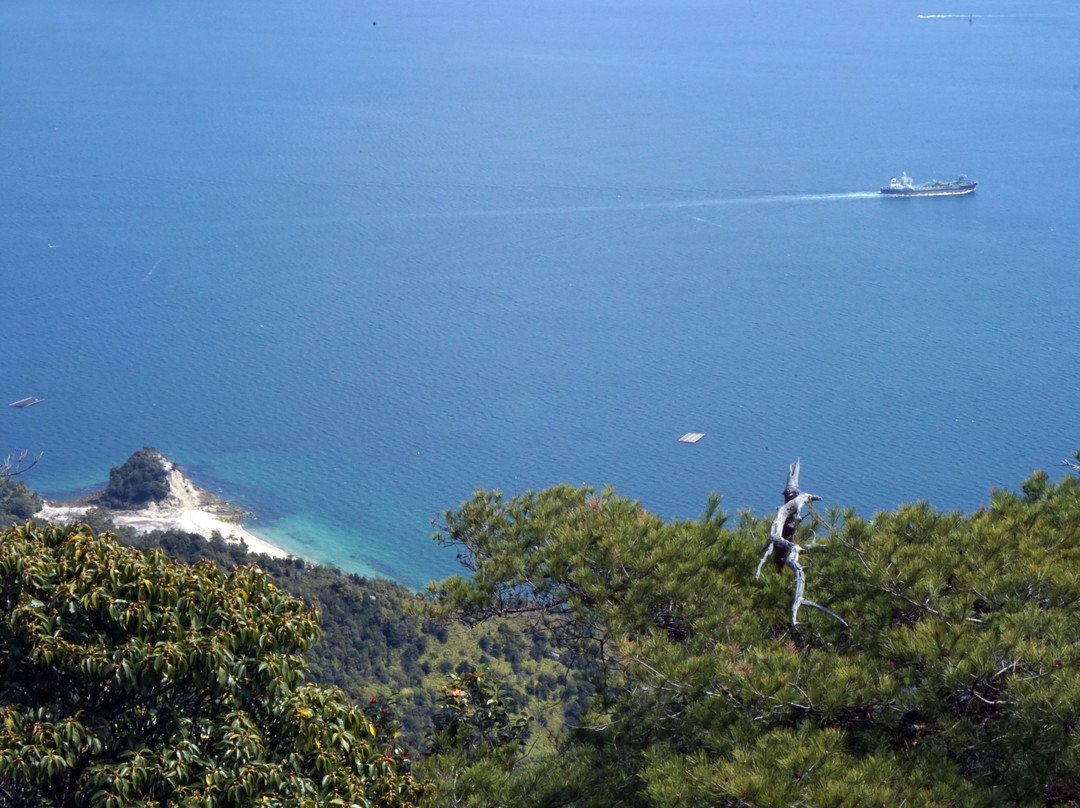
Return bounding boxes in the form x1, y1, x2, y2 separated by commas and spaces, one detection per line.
75, 508, 593, 753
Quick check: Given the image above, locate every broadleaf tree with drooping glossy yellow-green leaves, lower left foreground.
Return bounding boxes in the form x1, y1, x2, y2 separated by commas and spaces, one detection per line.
0, 523, 422, 808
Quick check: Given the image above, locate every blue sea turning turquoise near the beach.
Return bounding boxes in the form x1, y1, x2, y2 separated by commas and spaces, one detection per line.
0, 0, 1080, 587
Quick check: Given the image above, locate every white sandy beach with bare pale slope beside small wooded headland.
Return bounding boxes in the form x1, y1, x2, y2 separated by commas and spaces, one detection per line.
35, 466, 291, 558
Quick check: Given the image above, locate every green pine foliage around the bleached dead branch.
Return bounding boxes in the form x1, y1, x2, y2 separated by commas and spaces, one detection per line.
425, 460, 1080, 808
